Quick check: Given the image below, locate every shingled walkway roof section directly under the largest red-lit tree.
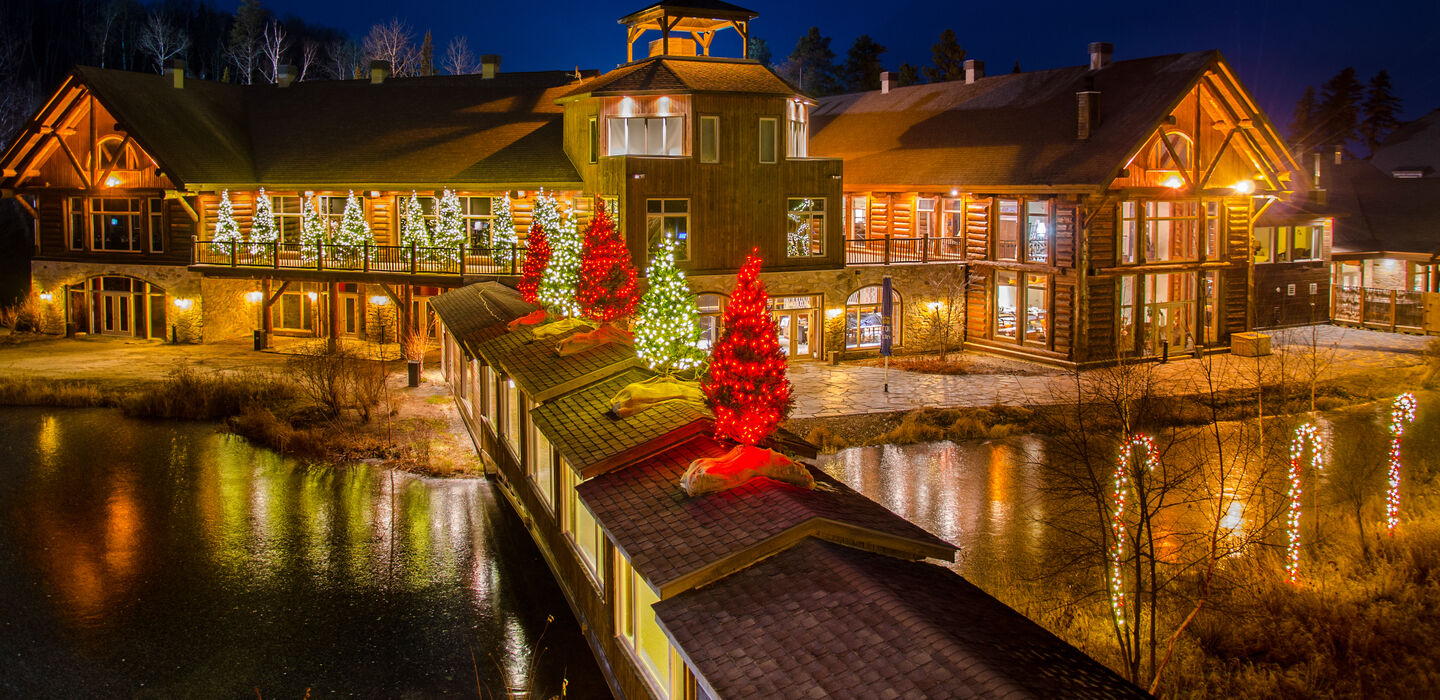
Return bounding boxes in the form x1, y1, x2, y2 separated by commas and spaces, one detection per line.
576, 436, 955, 598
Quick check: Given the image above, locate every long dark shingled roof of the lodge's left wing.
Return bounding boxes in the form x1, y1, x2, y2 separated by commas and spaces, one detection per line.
64, 68, 593, 187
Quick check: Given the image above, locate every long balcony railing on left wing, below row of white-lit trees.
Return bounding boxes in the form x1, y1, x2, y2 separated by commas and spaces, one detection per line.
192, 241, 526, 277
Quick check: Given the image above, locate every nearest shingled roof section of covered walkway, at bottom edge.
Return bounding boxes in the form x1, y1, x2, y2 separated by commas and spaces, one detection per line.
655, 540, 1149, 699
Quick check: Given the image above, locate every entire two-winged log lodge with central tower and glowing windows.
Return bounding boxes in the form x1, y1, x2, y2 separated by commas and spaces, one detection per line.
0, 0, 1307, 364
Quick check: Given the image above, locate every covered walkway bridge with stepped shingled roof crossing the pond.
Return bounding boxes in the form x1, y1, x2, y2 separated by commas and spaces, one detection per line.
432, 282, 1148, 699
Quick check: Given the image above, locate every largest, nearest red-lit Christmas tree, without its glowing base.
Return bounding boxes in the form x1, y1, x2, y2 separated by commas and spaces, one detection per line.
700, 249, 793, 445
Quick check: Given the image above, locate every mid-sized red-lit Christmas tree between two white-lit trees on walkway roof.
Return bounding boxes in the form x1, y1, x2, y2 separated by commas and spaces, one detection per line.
575, 202, 639, 323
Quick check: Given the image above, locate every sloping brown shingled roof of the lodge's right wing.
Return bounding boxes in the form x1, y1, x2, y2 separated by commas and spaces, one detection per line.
809, 50, 1220, 187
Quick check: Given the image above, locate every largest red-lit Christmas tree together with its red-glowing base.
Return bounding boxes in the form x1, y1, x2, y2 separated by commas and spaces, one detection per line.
681, 249, 815, 495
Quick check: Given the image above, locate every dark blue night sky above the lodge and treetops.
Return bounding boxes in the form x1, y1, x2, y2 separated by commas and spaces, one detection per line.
275, 0, 1440, 128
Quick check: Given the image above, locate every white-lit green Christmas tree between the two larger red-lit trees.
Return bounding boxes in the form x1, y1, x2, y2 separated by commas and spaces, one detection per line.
634, 236, 706, 374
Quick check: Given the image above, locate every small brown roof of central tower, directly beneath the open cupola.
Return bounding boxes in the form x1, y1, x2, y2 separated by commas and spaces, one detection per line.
564, 56, 802, 99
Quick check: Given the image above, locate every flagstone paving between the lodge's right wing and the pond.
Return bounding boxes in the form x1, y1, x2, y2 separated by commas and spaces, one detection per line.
791, 326, 1430, 418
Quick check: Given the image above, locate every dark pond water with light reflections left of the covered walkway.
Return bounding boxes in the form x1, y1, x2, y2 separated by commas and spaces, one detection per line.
0, 409, 609, 697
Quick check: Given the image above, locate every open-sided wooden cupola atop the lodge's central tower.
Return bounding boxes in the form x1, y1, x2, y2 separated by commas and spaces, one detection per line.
621, 0, 759, 62
